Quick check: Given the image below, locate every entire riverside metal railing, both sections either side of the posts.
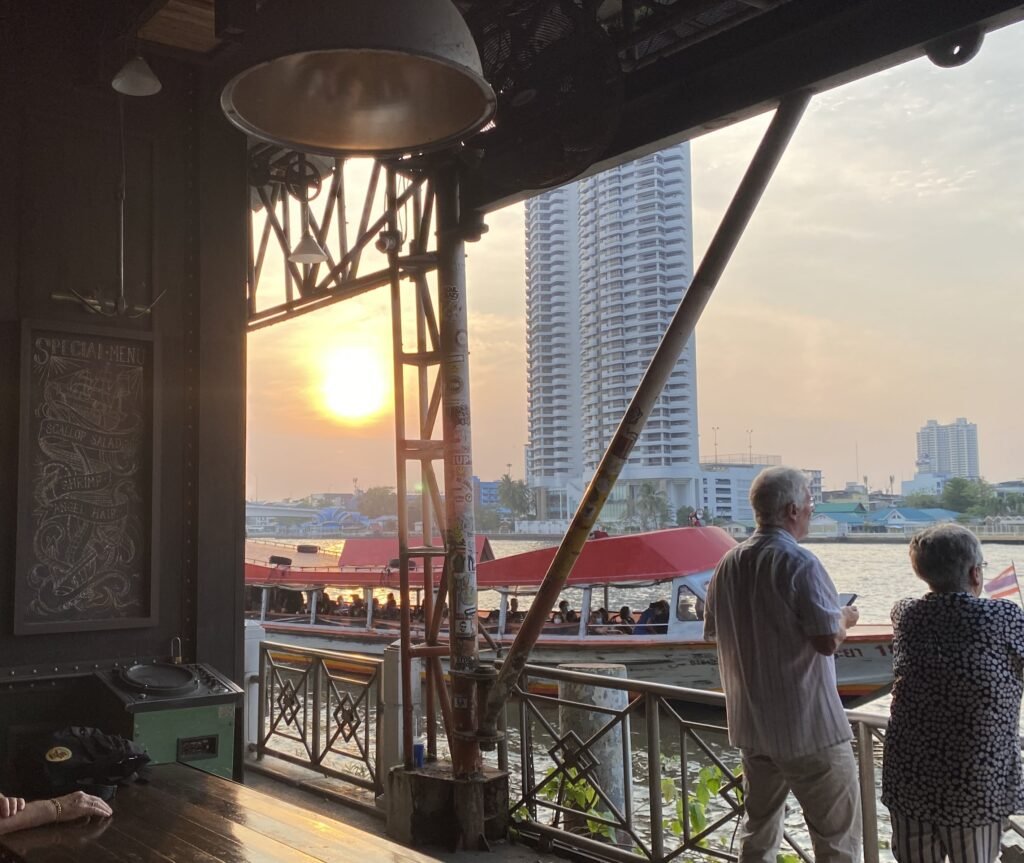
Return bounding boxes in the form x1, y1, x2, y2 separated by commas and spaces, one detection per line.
247, 642, 1024, 863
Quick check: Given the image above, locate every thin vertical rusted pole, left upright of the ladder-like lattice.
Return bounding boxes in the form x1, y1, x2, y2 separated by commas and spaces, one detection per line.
385, 167, 416, 770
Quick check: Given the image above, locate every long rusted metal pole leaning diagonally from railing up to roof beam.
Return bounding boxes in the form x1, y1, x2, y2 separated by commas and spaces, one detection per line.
480, 93, 810, 728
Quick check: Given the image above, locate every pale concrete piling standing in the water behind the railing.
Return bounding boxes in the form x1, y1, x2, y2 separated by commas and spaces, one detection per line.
558, 662, 633, 839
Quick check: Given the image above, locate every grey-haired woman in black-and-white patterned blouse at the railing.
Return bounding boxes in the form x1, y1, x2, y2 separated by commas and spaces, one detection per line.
882, 524, 1024, 863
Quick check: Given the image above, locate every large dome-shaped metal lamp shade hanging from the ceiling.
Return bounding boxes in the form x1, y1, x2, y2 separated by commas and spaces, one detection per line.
220, 0, 495, 156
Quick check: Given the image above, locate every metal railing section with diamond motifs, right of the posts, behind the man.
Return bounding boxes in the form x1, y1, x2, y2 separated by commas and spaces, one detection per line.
498, 665, 888, 863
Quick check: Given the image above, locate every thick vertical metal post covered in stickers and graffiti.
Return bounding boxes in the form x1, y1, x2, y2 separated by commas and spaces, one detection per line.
435, 161, 482, 778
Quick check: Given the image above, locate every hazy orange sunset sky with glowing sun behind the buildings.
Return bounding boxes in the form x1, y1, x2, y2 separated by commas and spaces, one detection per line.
247, 25, 1024, 500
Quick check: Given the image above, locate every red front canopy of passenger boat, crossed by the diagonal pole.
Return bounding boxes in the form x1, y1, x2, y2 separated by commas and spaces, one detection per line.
476, 527, 736, 589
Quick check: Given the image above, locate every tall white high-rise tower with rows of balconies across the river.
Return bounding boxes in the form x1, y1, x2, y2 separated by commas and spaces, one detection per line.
526, 143, 699, 521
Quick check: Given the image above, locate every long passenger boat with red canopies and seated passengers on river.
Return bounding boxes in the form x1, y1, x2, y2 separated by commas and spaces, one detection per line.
246, 527, 892, 706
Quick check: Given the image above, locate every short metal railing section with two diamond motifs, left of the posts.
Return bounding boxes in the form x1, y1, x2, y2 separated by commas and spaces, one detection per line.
256, 642, 384, 793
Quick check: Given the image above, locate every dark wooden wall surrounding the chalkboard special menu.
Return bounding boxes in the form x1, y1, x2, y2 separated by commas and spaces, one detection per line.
0, 0, 247, 679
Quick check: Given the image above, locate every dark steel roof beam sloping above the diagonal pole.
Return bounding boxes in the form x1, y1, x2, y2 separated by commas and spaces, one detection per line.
463, 0, 1024, 211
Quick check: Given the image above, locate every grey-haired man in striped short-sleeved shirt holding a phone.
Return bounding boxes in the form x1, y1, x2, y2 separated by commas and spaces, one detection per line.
705, 467, 861, 863
